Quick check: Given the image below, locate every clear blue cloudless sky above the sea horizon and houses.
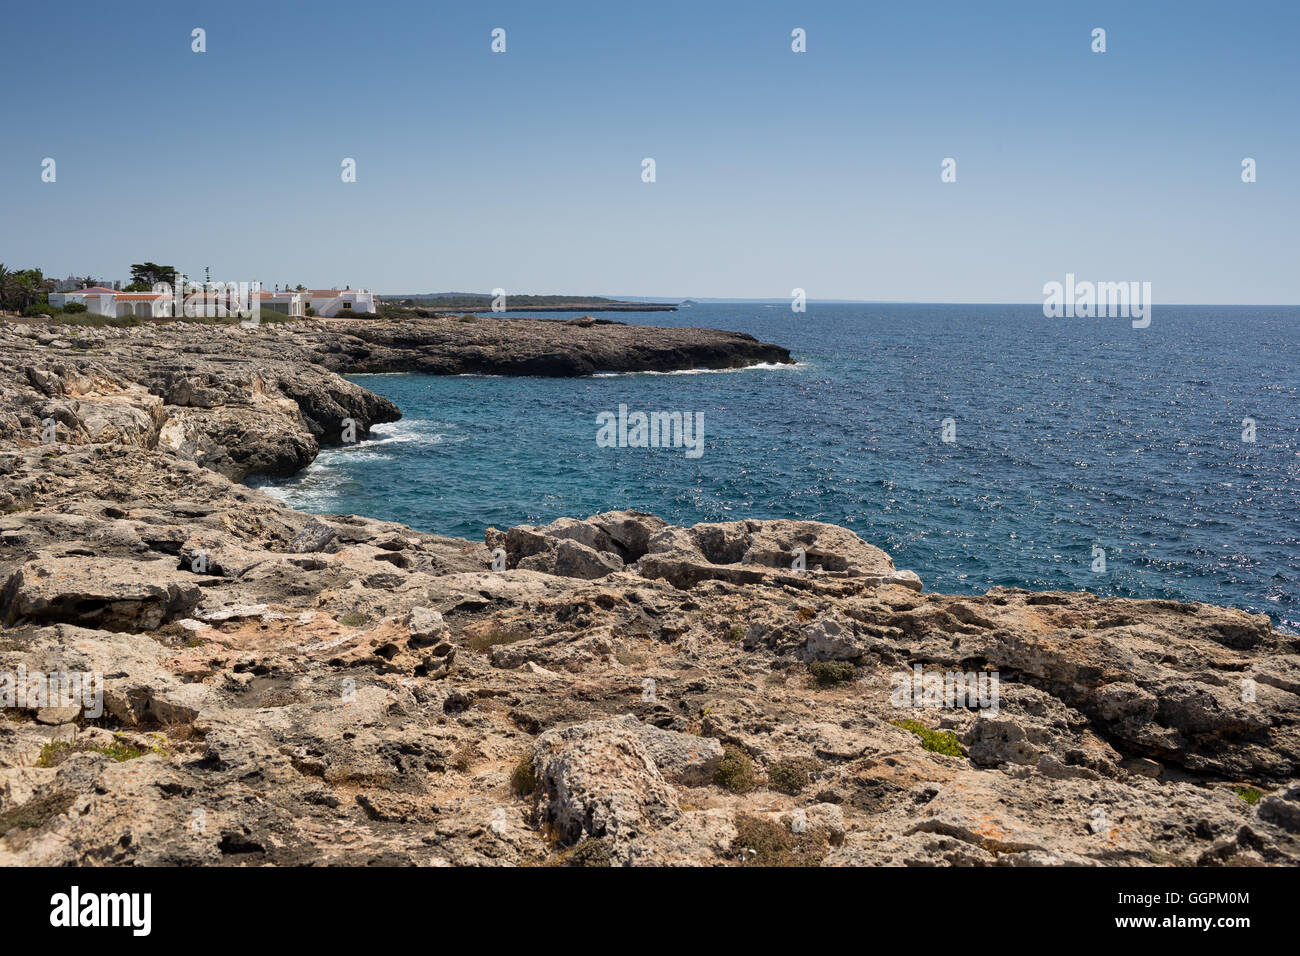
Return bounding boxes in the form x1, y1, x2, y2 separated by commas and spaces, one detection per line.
0, 0, 1300, 304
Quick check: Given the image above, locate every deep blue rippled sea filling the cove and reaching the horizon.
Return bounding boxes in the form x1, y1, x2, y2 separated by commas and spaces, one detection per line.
253, 302, 1300, 631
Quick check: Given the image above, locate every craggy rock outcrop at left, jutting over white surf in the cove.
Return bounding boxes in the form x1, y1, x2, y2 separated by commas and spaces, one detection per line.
0, 325, 400, 480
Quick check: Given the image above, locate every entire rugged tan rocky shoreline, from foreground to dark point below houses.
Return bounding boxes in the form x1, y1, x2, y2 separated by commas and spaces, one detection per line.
0, 319, 1300, 866
